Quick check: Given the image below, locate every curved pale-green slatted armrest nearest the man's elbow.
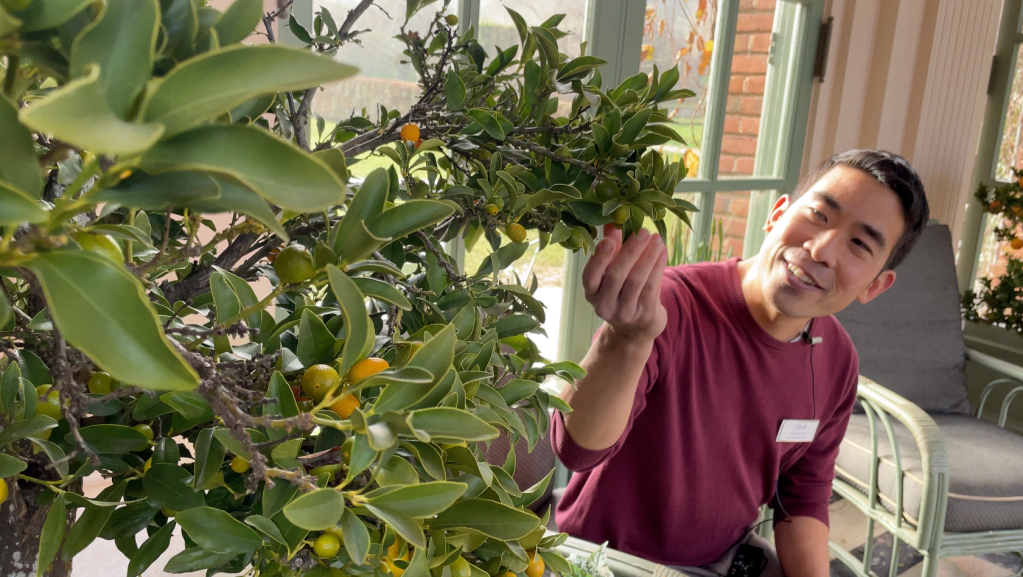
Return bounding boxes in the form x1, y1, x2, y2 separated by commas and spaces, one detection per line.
856, 376, 948, 547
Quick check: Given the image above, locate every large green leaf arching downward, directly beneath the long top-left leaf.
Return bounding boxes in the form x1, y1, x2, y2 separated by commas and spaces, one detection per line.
141, 123, 345, 213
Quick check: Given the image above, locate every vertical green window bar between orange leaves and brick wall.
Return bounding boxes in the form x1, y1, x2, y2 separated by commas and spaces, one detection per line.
690, 0, 739, 258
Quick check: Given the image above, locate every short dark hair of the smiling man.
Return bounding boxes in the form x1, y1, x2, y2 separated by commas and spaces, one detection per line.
792, 150, 931, 270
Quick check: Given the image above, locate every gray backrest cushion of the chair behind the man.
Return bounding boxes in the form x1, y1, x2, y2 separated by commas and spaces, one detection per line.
835, 224, 970, 414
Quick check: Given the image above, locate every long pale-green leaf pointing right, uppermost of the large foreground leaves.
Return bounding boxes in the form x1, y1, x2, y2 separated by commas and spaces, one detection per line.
142, 44, 359, 136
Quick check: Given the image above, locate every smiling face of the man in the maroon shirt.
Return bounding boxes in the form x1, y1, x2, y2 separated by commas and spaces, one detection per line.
757, 165, 905, 318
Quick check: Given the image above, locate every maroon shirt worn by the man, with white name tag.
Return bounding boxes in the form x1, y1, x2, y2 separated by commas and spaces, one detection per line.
551, 259, 858, 567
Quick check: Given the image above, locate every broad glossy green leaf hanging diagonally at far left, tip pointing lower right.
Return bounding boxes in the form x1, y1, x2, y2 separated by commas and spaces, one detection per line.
28, 251, 198, 390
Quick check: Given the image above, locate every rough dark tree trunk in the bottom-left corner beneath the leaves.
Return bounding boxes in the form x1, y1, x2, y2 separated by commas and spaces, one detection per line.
0, 479, 74, 577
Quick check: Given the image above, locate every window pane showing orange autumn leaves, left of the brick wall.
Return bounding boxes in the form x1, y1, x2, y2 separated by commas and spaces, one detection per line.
639, 0, 717, 169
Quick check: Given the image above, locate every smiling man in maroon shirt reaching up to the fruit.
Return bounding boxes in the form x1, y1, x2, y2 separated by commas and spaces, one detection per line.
551, 150, 929, 577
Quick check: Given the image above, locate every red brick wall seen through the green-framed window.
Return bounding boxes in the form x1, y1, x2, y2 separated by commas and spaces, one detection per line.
714, 0, 776, 256
